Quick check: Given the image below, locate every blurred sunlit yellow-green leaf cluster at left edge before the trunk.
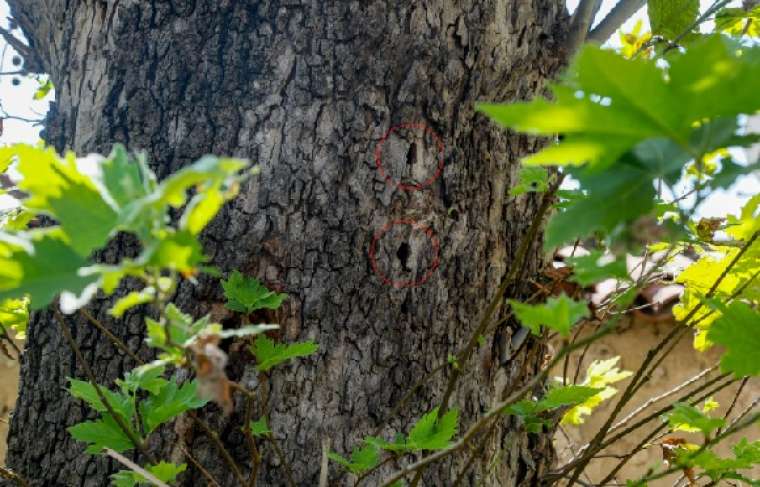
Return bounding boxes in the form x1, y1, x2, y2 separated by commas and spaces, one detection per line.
0, 145, 252, 314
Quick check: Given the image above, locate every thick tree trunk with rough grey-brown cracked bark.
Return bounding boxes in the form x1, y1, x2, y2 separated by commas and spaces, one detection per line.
7, 0, 565, 486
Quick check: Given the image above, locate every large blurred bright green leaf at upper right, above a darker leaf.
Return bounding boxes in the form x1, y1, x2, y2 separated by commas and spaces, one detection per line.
477, 36, 760, 172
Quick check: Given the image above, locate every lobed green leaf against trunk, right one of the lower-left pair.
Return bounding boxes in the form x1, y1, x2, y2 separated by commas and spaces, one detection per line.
140, 381, 208, 433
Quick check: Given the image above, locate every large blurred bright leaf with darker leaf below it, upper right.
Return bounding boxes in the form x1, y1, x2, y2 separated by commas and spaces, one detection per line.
478, 36, 760, 248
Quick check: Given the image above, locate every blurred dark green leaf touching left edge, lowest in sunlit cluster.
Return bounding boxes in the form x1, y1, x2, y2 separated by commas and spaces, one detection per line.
0, 231, 95, 310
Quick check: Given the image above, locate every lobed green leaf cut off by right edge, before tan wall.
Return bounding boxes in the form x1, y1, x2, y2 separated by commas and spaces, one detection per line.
707, 302, 760, 377
